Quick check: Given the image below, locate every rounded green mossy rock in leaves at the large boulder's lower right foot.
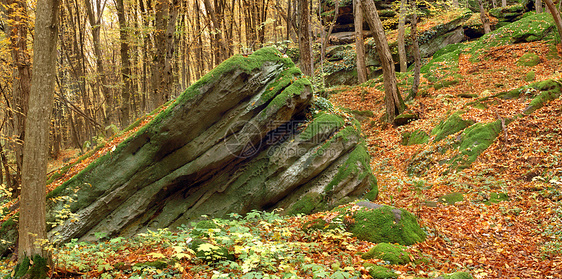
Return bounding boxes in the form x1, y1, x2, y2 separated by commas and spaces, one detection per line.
348, 202, 425, 245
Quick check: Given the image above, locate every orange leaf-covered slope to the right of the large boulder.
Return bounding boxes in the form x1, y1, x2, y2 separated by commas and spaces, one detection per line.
330, 42, 562, 278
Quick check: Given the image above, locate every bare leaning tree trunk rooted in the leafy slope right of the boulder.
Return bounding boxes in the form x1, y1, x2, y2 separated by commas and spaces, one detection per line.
362, 0, 405, 123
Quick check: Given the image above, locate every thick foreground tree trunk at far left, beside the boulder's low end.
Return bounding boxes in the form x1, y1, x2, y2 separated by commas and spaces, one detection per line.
18, 0, 59, 263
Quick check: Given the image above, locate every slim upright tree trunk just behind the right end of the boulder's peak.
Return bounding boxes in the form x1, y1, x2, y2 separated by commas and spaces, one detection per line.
298, 0, 313, 76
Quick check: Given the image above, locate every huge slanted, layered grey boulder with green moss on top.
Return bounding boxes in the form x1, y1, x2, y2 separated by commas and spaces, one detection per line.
2, 48, 377, 252
